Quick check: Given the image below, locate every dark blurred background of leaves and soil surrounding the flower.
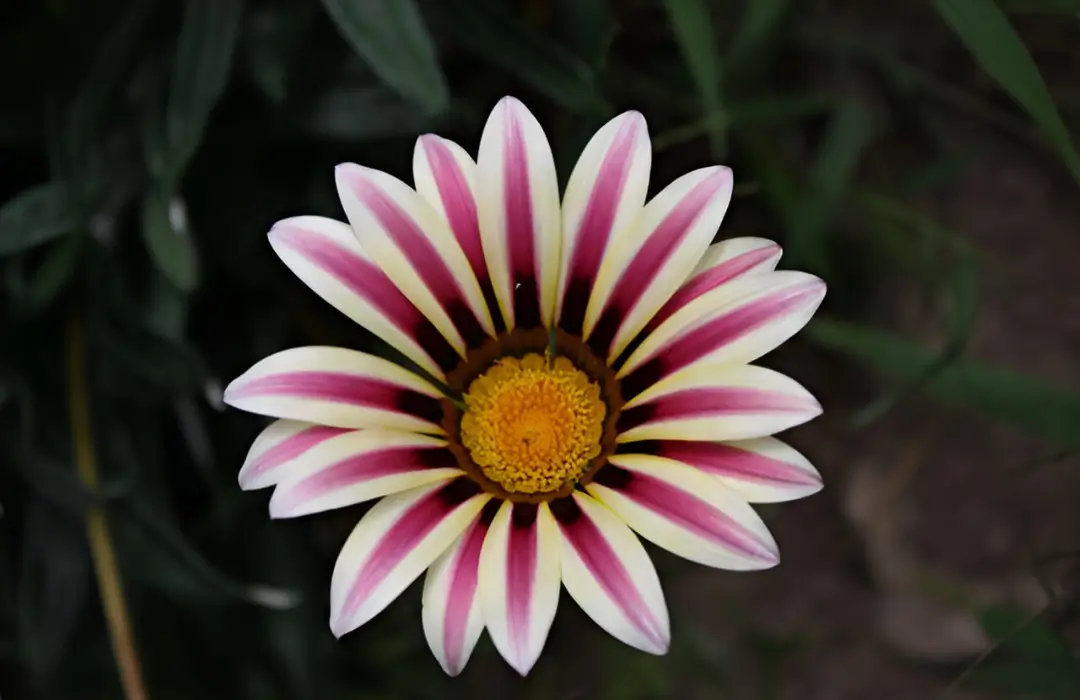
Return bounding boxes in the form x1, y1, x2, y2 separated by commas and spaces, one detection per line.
0, 0, 1080, 700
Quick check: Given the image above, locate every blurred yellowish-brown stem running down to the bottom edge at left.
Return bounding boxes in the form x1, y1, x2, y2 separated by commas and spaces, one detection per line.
67, 311, 147, 700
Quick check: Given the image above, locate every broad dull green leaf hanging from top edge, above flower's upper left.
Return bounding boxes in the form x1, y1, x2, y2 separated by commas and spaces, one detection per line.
323, 0, 450, 115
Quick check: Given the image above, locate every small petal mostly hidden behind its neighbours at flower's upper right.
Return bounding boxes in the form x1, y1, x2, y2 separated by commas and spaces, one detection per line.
644, 237, 782, 334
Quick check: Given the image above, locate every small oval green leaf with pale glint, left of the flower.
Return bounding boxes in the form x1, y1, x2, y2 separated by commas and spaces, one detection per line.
141, 188, 199, 292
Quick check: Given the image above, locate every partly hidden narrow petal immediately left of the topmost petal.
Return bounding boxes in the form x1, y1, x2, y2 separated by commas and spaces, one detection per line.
413, 134, 501, 328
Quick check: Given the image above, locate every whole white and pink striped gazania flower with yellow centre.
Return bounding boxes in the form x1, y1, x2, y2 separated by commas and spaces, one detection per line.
225, 97, 825, 674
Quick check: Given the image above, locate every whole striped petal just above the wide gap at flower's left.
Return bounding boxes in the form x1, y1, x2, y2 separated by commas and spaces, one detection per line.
269, 216, 460, 378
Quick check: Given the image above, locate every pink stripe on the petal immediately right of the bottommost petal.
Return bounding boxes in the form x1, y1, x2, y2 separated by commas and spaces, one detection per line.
553, 498, 667, 648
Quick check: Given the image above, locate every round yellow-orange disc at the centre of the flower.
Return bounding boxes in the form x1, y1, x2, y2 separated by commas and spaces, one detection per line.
461, 353, 607, 496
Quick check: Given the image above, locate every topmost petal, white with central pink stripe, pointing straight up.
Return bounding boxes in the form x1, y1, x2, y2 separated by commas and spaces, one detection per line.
476, 97, 562, 328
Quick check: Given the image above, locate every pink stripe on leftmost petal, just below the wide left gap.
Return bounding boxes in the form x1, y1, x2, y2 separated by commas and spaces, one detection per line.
231, 372, 443, 425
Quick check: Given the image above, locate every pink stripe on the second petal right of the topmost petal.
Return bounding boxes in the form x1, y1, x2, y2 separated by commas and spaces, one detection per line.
589, 169, 730, 358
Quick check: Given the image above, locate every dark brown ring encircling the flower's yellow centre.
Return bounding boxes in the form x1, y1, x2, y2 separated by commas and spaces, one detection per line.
442, 328, 623, 503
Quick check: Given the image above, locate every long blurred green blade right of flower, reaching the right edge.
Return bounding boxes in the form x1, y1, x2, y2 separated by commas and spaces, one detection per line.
808, 319, 1080, 447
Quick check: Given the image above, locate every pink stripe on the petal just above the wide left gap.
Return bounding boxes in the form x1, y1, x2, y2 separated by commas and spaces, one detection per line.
270, 223, 461, 371
